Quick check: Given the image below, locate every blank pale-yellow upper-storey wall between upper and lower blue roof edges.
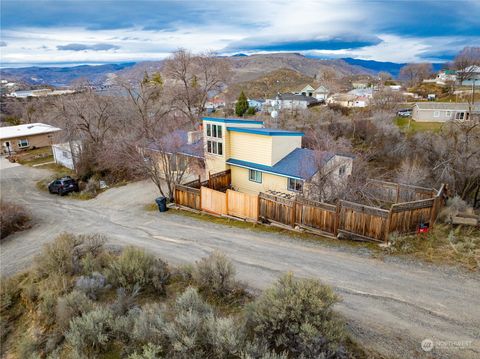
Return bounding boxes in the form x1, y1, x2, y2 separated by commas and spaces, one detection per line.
230, 132, 272, 166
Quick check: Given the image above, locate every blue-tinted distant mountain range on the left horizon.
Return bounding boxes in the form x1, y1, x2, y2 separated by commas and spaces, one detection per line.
0, 62, 135, 87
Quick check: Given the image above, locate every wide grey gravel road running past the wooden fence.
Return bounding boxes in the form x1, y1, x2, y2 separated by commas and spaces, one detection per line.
0, 166, 480, 358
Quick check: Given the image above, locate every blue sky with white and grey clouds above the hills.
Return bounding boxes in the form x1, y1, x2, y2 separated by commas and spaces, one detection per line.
0, 0, 480, 67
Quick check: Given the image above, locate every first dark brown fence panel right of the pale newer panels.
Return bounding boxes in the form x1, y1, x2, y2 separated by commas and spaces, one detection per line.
258, 193, 295, 227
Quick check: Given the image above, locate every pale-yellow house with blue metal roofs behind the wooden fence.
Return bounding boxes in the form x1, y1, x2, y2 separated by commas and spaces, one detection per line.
203, 117, 353, 195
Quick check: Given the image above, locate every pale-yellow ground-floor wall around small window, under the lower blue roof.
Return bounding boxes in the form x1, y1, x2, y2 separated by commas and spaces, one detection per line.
230, 166, 295, 194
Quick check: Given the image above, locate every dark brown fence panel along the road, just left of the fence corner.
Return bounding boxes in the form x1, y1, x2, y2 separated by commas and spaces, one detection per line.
338, 201, 389, 241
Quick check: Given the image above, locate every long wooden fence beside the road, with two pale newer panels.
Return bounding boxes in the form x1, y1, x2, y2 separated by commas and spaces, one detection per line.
175, 176, 446, 242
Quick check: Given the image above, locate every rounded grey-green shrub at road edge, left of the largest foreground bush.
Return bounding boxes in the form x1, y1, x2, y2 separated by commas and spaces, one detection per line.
193, 252, 239, 297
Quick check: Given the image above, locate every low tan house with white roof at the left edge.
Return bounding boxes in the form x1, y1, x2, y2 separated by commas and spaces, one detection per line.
0, 123, 61, 155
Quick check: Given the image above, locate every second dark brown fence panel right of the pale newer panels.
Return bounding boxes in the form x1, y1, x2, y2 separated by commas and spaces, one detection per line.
295, 198, 337, 234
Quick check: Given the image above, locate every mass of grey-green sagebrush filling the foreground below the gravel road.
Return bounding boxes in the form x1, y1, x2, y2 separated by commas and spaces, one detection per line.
0, 234, 356, 359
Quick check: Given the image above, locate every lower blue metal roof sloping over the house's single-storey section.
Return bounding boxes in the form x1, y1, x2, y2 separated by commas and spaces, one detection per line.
227, 148, 335, 180
